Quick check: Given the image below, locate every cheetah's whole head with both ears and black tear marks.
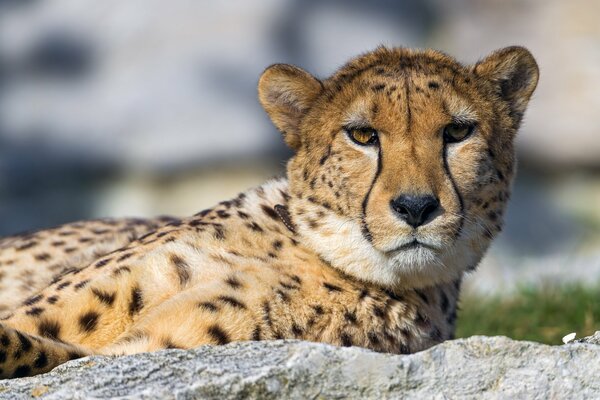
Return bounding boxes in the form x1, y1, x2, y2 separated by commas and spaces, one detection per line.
259, 47, 538, 287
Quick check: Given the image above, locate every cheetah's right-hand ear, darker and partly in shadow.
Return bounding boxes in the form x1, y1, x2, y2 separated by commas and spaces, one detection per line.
473, 46, 539, 126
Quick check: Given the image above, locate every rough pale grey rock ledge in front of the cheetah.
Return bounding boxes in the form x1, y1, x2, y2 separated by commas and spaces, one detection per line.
0, 334, 600, 399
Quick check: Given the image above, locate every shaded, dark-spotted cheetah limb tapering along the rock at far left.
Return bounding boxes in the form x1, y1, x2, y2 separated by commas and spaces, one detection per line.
0, 324, 91, 379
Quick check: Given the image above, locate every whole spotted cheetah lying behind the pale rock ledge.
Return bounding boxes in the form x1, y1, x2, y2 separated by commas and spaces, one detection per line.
0, 47, 539, 378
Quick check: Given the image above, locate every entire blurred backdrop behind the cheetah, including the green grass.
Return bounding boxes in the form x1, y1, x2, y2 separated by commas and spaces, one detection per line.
0, 0, 600, 343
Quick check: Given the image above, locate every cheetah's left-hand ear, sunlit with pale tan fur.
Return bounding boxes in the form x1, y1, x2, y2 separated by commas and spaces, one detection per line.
258, 64, 323, 150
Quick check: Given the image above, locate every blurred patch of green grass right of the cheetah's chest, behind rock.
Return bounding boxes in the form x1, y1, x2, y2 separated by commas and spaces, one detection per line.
456, 284, 600, 344
